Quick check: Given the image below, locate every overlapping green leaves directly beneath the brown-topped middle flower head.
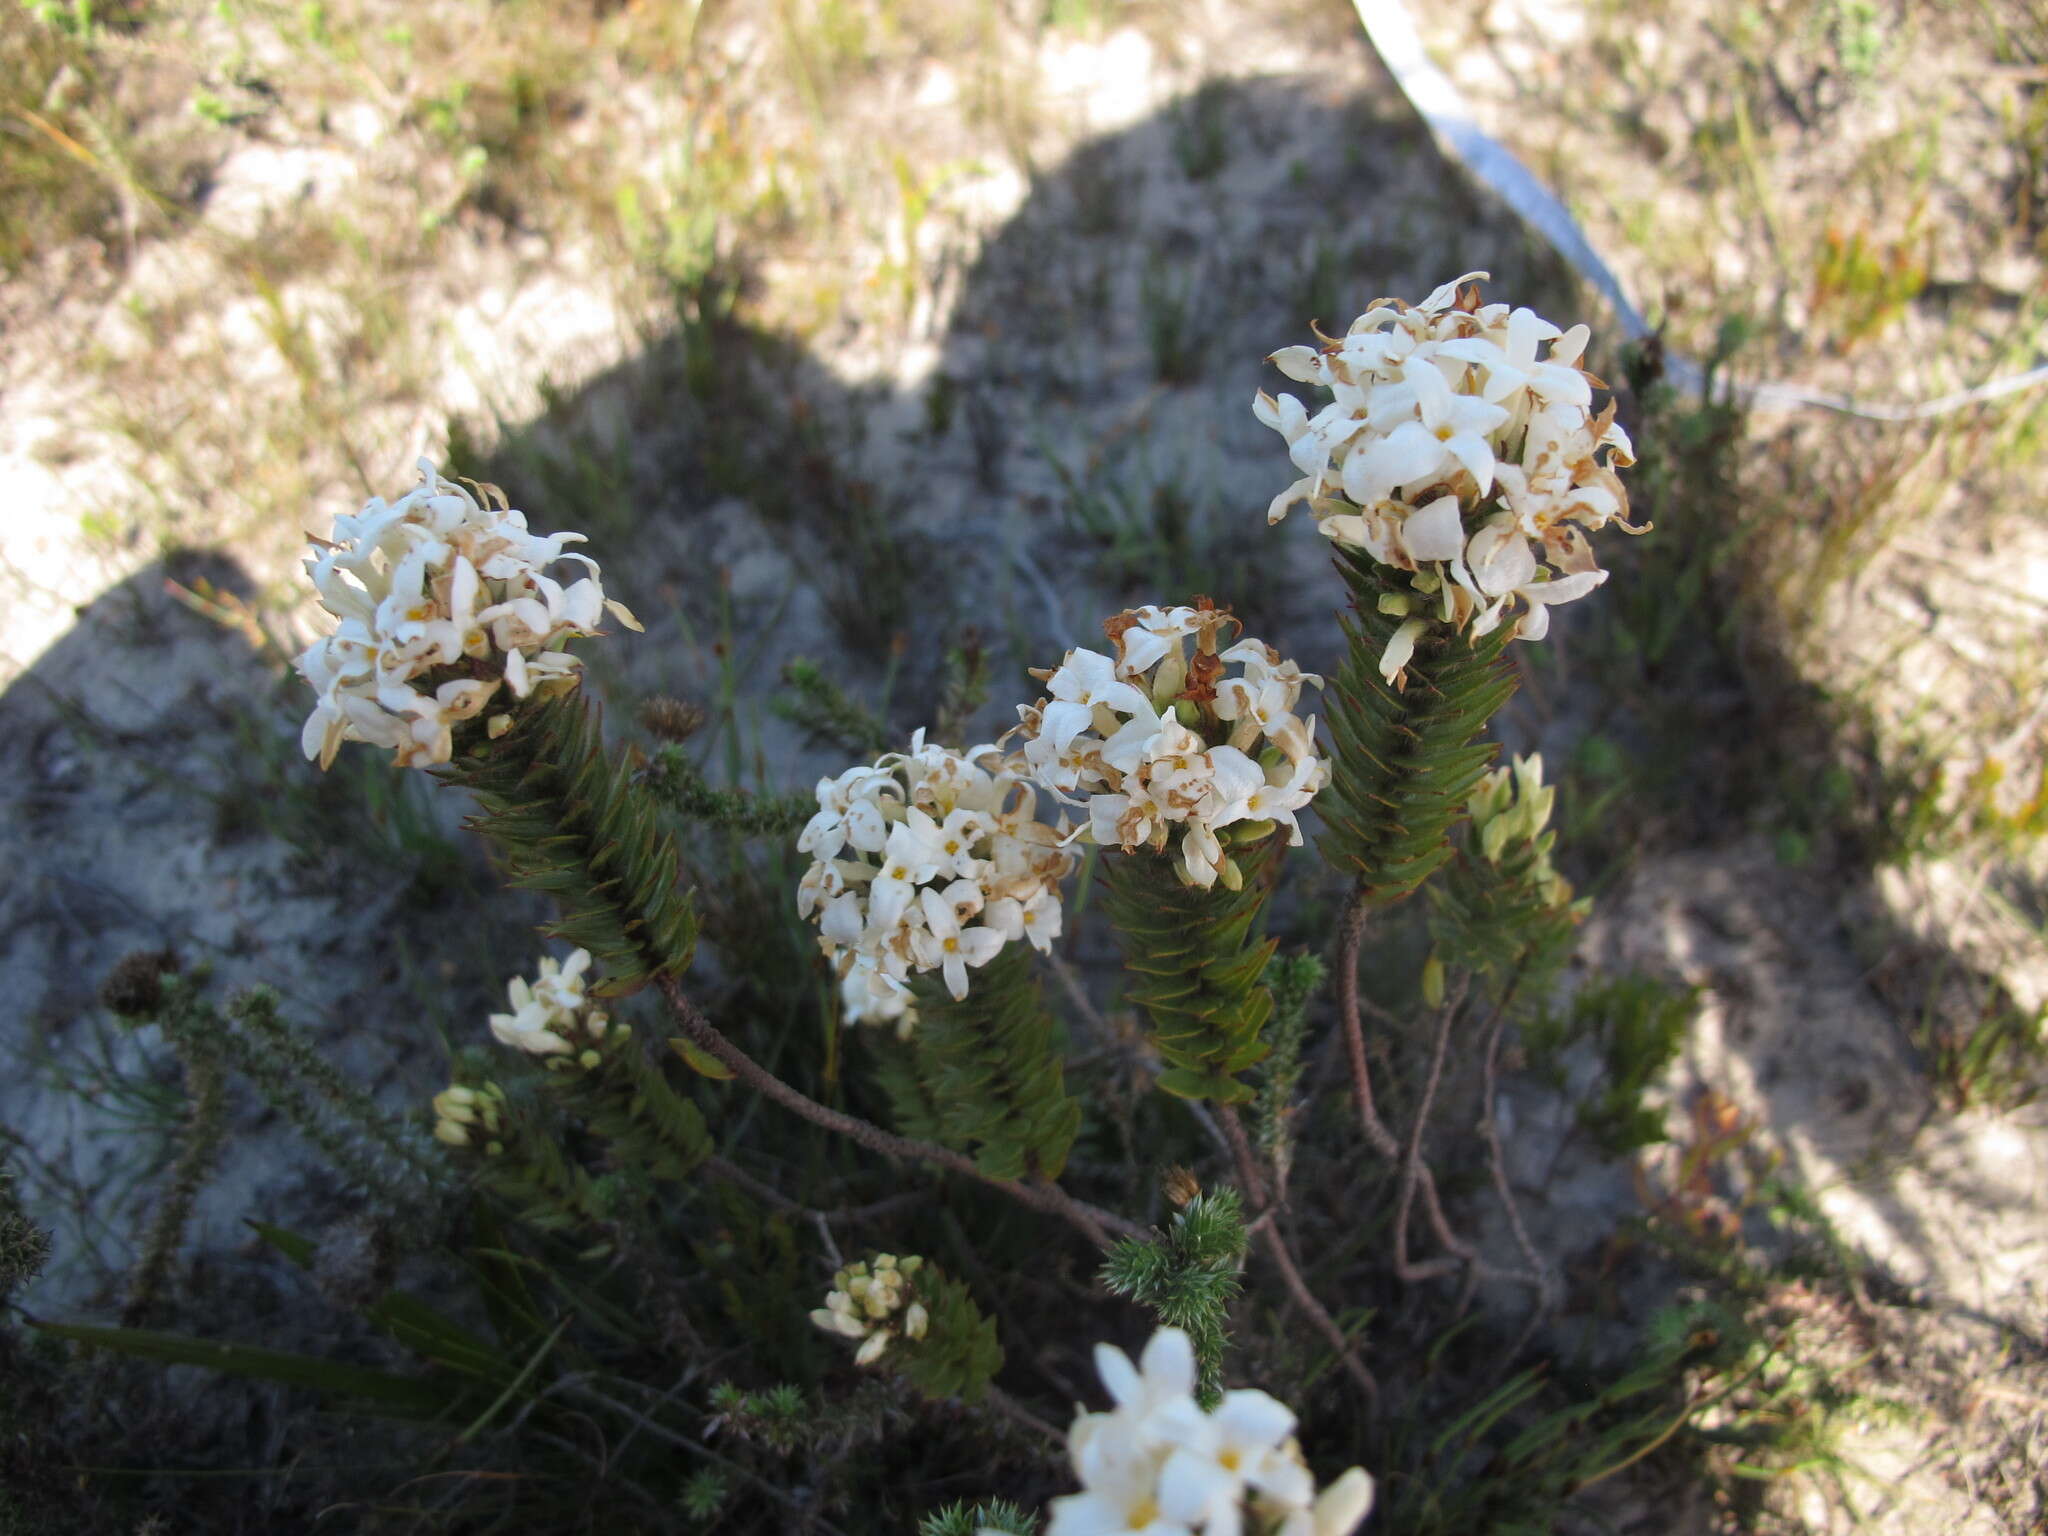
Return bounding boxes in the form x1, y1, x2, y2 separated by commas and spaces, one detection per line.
1102, 831, 1286, 1104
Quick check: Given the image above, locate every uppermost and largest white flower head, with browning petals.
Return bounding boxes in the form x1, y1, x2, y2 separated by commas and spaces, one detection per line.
1253, 272, 1645, 680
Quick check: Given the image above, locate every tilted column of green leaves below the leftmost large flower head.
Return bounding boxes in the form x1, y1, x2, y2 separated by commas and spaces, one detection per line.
438, 688, 696, 995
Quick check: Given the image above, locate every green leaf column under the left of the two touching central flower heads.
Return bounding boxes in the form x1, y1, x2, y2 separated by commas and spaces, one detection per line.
883, 944, 1081, 1180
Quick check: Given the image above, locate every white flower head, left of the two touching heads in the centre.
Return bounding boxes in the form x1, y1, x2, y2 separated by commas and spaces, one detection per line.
797, 731, 1075, 1034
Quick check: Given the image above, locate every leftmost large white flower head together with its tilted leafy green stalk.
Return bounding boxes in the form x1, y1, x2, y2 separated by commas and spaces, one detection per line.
295, 459, 696, 993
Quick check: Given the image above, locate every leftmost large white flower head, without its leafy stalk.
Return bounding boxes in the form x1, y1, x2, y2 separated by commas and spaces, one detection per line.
295, 459, 639, 768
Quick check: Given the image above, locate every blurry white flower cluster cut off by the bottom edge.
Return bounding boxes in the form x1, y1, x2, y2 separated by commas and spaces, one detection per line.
1019, 1327, 1372, 1536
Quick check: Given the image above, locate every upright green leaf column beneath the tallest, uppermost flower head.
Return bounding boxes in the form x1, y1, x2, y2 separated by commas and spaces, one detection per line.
1315, 549, 1513, 907
